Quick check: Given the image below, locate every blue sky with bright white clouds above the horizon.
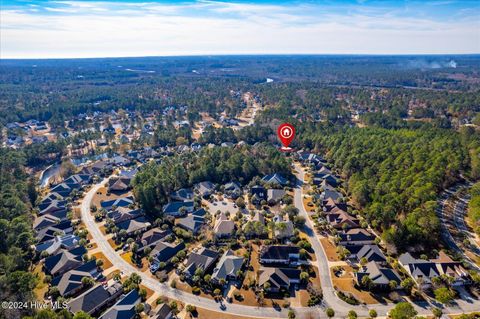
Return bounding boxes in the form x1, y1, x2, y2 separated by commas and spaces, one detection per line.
0, 0, 480, 58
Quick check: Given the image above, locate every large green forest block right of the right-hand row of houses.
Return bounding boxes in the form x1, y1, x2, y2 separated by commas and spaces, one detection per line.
300, 125, 480, 250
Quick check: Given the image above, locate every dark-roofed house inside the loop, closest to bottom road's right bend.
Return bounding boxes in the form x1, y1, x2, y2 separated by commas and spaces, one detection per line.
258, 267, 301, 293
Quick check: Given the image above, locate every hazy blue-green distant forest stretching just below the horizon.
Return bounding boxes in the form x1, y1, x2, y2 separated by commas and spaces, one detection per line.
0, 55, 480, 125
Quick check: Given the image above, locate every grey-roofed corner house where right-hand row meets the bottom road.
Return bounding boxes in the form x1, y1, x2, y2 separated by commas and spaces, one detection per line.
354, 261, 401, 289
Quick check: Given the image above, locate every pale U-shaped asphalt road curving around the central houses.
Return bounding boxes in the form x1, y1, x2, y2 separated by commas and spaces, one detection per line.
80, 175, 480, 319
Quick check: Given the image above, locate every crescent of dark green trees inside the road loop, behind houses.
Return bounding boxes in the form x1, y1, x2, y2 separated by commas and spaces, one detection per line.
133, 144, 291, 214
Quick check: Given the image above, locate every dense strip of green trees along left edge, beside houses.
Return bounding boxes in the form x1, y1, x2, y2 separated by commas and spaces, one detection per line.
0, 148, 38, 318
